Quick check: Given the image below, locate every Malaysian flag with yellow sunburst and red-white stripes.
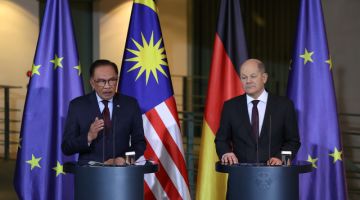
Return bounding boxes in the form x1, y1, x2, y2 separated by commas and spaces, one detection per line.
119, 0, 190, 199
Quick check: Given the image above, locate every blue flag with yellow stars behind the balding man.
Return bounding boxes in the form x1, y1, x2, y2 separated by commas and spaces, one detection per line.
287, 0, 347, 200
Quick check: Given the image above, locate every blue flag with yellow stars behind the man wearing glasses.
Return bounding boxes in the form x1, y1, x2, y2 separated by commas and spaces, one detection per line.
14, 0, 83, 200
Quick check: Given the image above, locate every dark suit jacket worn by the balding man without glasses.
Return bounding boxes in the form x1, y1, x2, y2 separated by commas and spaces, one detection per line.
215, 94, 300, 163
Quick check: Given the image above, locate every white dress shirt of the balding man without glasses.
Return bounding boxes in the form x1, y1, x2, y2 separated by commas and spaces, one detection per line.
246, 90, 268, 136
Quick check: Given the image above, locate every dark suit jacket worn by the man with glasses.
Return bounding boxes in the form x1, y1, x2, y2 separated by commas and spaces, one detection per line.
61, 92, 146, 163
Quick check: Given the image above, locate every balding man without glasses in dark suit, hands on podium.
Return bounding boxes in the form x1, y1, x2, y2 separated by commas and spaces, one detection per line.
215, 59, 300, 165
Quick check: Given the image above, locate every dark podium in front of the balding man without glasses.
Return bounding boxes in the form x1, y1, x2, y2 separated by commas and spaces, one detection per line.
215, 162, 312, 200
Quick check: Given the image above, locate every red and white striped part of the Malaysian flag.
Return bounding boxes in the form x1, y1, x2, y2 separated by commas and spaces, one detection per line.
142, 96, 190, 199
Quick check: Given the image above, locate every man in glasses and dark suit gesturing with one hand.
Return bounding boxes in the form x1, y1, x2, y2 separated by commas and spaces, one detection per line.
61, 60, 146, 165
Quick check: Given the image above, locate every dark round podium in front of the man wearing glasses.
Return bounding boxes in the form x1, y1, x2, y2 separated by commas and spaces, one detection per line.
64, 164, 158, 200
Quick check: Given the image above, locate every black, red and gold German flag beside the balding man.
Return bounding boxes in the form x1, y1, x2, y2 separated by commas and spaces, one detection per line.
196, 0, 247, 200
